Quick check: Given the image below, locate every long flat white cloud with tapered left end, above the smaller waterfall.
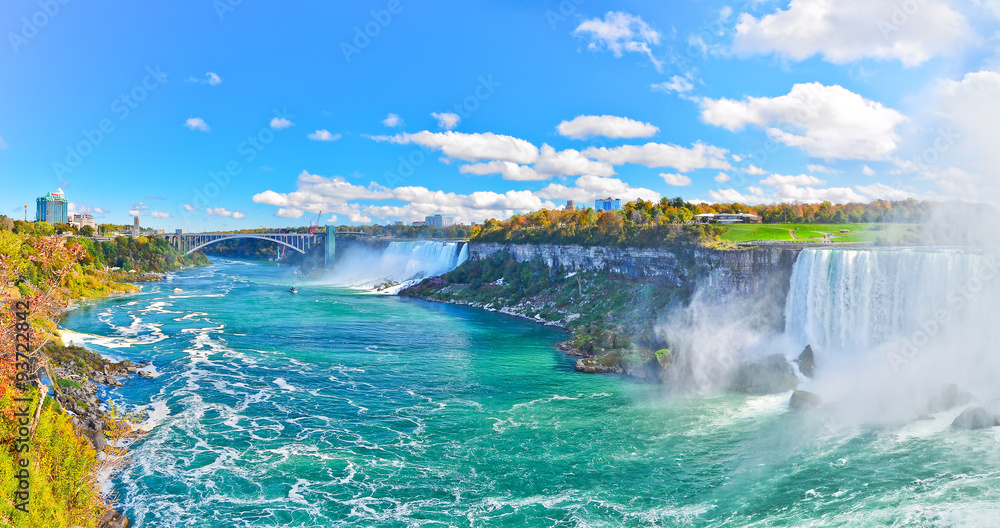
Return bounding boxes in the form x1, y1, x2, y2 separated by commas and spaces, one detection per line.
373, 130, 538, 164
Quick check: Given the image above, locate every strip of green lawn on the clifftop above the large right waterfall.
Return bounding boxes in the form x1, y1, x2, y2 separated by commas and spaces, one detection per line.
722, 224, 916, 242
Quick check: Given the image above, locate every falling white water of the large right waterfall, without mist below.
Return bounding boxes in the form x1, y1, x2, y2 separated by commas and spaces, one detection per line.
785, 248, 1000, 354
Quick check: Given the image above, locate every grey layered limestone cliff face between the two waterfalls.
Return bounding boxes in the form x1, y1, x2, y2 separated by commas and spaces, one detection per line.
469, 242, 798, 293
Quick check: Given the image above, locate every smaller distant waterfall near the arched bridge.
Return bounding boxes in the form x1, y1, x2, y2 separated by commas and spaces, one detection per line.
329, 241, 469, 293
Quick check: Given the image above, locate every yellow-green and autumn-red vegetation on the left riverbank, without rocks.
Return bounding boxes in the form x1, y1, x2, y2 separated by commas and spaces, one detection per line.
0, 225, 207, 528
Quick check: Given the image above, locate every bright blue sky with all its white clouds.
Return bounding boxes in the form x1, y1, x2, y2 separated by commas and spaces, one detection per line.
0, 0, 1000, 231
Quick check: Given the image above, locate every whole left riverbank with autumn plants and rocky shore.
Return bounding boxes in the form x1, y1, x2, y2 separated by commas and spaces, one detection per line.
0, 229, 208, 528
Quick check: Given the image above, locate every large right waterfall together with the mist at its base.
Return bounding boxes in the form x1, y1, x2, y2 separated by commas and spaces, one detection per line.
783, 248, 1000, 423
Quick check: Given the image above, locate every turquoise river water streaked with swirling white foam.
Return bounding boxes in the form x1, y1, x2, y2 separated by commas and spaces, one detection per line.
61, 255, 1000, 528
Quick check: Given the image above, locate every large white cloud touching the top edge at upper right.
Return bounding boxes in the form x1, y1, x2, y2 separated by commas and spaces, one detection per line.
733, 0, 975, 66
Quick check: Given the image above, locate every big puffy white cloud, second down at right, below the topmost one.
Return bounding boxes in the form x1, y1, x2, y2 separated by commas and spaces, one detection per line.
701, 83, 906, 160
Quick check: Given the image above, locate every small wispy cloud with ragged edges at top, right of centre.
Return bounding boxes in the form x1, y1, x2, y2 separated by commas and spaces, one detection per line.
573, 11, 663, 71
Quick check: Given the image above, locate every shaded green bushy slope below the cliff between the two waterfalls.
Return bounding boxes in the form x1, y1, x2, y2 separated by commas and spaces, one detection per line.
400, 251, 692, 377
